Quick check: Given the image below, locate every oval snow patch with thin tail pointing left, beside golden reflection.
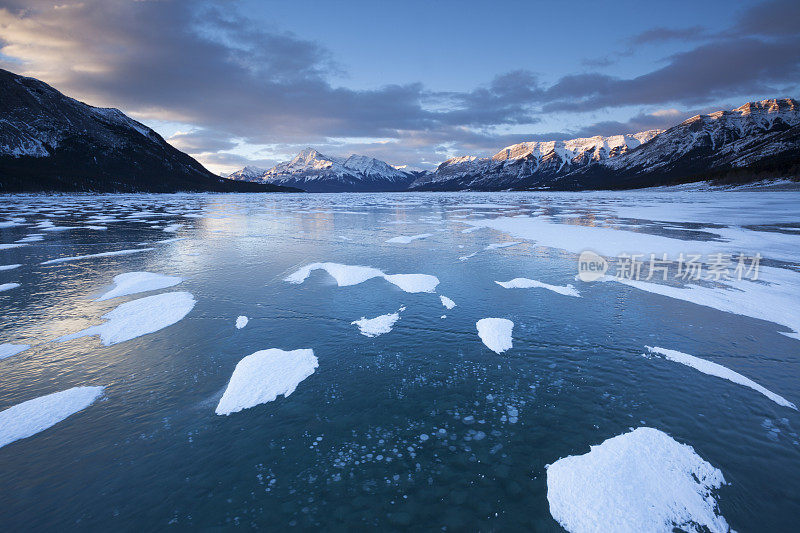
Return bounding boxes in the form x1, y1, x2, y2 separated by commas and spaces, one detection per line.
58, 292, 196, 346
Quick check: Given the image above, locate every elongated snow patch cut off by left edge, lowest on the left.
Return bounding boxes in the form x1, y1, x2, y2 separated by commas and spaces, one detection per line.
0, 387, 103, 448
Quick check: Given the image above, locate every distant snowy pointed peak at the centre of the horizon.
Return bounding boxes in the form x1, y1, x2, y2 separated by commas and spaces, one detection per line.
229, 148, 414, 192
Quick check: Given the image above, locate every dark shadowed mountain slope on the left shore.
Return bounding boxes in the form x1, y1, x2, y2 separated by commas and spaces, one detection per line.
0, 69, 296, 192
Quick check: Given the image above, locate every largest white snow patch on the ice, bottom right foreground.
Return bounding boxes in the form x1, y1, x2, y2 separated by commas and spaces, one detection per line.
547, 427, 730, 533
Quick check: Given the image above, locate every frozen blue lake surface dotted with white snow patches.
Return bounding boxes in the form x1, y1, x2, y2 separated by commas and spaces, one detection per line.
0, 191, 800, 531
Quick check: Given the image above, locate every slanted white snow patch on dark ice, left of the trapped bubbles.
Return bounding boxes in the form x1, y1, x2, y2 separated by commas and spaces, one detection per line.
215, 348, 319, 415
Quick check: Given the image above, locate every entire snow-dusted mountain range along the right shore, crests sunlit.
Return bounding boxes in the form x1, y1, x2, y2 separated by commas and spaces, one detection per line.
411, 98, 800, 190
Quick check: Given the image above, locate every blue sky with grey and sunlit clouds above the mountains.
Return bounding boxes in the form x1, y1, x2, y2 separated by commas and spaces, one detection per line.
0, 0, 800, 172
